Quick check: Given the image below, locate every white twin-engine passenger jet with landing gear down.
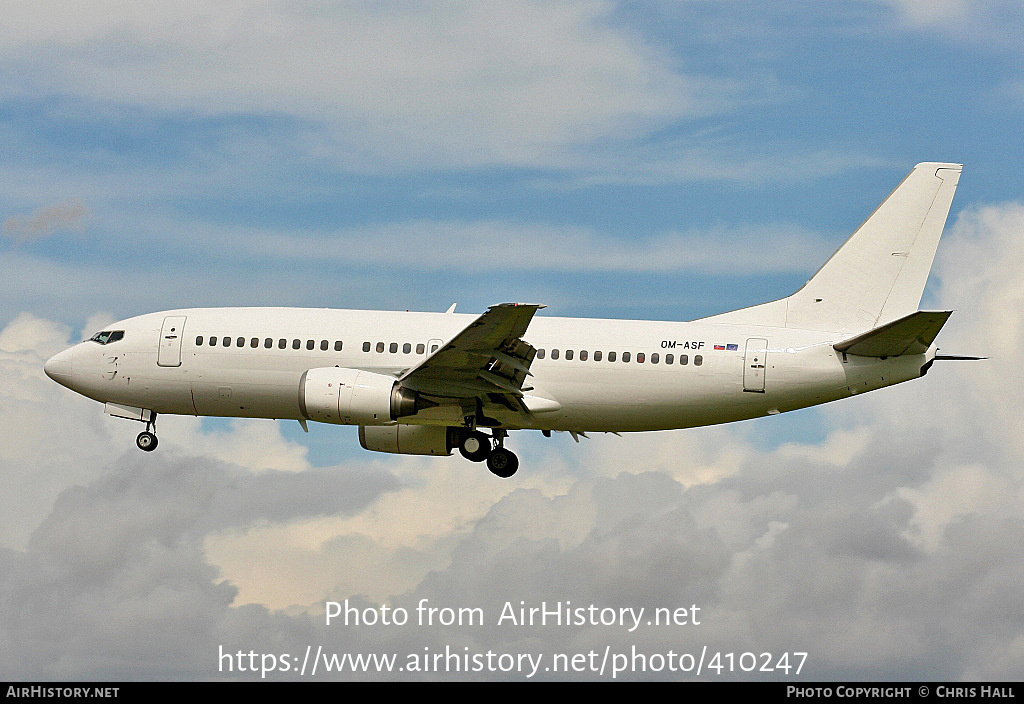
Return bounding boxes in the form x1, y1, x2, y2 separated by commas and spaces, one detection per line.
45, 163, 976, 477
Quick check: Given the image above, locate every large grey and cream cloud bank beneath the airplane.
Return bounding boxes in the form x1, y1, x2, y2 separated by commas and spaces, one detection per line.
6, 204, 1024, 679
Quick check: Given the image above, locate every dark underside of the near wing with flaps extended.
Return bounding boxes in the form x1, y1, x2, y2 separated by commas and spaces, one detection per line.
398, 303, 544, 409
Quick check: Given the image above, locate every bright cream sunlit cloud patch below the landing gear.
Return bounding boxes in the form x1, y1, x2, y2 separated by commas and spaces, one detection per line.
205, 457, 569, 609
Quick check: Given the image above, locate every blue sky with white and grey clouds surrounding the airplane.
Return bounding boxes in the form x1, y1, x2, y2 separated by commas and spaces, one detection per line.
0, 0, 1024, 680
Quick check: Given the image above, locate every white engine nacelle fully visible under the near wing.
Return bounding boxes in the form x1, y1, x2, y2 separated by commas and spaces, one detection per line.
299, 366, 425, 426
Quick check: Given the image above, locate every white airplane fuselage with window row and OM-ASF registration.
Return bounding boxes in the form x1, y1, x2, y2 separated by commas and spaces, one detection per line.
47, 308, 935, 432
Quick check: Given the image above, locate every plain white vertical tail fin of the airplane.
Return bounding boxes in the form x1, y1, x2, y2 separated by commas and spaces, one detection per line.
706, 162, 963, 333
